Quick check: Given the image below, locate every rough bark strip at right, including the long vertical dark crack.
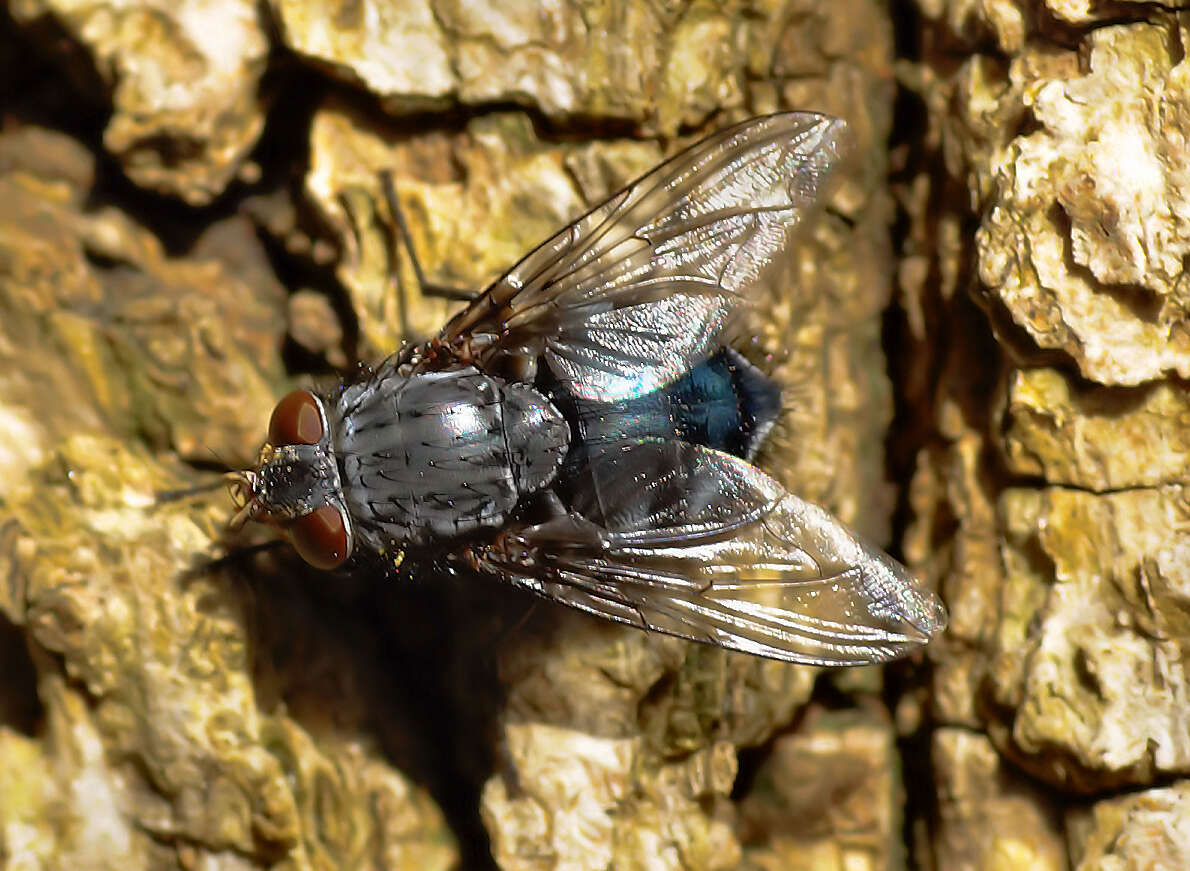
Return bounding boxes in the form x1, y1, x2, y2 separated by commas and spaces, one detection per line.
897, 2, 1190, 869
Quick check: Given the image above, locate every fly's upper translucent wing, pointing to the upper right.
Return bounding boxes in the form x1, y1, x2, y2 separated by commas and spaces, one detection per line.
439, 113, 844, 402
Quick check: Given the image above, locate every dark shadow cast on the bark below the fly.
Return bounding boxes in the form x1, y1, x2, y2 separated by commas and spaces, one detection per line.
163, 488, 551, 870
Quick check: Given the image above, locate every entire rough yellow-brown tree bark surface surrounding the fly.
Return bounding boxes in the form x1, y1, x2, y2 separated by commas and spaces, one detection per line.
0, 0, 1190, 871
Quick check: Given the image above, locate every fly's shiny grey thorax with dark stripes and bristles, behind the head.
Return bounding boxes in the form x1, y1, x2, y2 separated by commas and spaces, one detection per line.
331, 365, 570, 550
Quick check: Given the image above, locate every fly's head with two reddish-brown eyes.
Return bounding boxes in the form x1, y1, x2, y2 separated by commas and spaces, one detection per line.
232, 390, 355, 569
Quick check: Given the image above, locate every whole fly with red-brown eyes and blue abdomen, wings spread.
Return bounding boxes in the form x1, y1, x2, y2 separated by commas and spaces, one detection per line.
234, 113, 946, 665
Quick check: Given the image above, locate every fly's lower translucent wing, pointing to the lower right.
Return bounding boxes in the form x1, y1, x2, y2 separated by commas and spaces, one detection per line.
477, 440, 946, 665
